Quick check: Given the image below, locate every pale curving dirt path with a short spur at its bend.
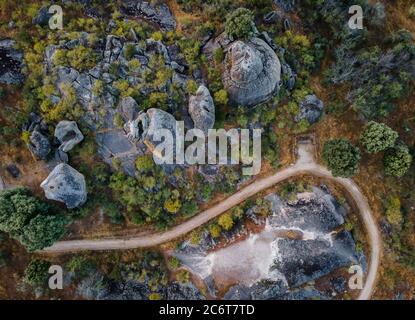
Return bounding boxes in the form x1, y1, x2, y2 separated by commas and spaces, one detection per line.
42, 145, 382, 300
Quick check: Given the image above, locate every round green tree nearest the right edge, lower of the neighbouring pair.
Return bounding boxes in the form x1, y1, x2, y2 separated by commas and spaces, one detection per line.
383, 144, 412, 178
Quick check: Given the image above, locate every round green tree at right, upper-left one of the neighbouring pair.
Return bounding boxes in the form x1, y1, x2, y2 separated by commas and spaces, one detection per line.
360, 121, 399, 153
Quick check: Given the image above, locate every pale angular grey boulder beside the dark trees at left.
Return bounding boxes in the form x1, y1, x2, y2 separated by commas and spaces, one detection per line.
40, 163, 87, 209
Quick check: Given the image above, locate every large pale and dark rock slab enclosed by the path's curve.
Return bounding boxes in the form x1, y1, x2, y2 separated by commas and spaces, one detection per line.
174, 186, 365, 300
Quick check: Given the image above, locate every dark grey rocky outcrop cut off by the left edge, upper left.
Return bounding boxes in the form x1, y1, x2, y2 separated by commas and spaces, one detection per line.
0, 39, 24, 84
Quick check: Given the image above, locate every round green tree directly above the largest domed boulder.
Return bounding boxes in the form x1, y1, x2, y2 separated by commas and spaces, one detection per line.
225, 8, 255, 39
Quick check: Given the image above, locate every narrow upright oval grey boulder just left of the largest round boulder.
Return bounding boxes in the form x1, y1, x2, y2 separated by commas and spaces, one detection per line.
189, 85, 215, 135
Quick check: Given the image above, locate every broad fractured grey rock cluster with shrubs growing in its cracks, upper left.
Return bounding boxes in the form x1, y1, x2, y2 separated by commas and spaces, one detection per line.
45, 25, 202, 176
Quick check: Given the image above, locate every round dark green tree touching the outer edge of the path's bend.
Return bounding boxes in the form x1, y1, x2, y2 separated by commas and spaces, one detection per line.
323, 139, 360, 178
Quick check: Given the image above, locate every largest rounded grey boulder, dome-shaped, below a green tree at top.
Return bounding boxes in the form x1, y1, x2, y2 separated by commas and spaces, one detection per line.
223, 38, 281, 106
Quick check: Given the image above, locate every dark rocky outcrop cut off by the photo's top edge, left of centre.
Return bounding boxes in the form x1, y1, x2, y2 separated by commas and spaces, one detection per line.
122, 0, 176, 31
